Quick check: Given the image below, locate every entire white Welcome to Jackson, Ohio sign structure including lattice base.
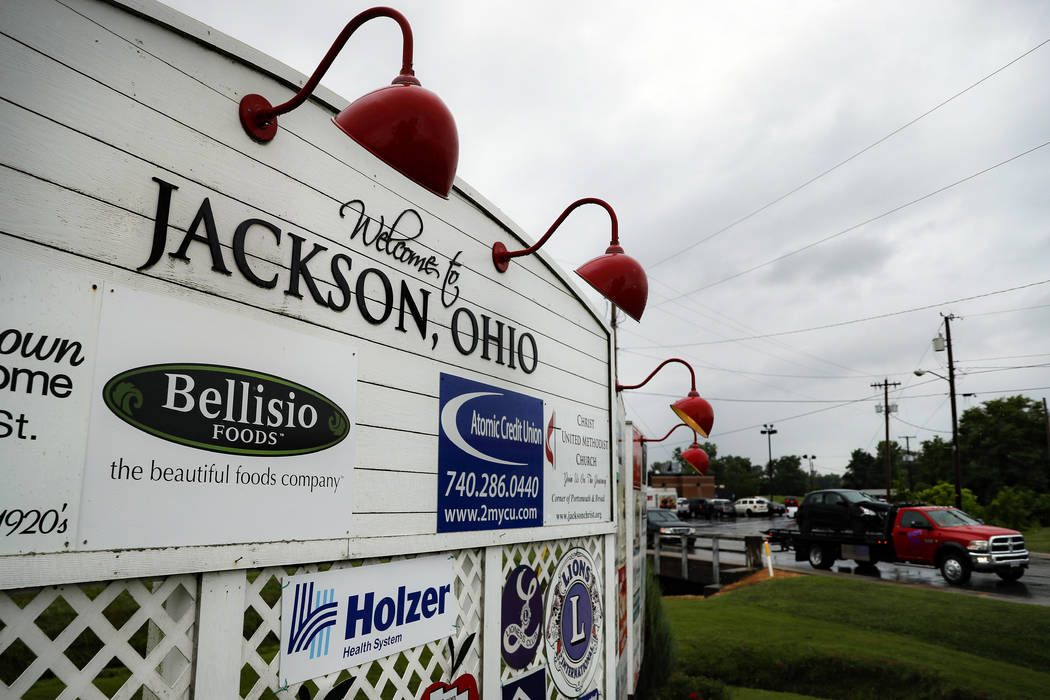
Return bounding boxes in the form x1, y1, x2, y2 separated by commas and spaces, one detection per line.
0, 0, 633, 700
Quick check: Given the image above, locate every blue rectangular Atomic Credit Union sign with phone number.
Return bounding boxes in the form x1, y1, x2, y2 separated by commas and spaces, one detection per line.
438, 374, 544, 532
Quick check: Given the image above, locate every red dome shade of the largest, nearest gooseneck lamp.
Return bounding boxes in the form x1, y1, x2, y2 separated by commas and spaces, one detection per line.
332, 76, 459, 198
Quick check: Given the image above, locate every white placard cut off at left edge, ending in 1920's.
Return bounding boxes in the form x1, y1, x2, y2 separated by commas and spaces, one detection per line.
0, 255, 102, 554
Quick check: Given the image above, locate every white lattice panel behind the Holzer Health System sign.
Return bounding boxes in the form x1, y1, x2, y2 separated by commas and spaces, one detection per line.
240, 549, 484, 700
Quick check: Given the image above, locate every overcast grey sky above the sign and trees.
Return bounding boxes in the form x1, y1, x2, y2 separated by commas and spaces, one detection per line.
159, 0, 1050, 473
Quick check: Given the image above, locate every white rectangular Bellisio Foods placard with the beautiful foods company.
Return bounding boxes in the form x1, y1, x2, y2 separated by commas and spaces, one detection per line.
79, 287, 357, 549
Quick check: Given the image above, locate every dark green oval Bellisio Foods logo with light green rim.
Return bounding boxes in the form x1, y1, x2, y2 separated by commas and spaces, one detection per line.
102, 364, 351, 457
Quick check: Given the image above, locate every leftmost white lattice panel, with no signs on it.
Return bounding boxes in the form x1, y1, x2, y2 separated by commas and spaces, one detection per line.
0, 575, 197, 700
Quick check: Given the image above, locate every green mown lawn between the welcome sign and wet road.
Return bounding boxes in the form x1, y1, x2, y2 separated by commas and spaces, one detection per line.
665, 576, 1050, 698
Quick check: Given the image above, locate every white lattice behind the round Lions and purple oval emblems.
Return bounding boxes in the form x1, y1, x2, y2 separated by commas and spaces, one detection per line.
497, 537, 615, 700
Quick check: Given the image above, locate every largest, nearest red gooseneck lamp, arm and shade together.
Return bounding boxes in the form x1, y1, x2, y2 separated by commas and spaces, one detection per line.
239, 7, 459, 198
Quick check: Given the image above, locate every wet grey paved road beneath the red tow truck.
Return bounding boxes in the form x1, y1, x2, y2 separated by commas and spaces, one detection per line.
669, 517, 1050, 606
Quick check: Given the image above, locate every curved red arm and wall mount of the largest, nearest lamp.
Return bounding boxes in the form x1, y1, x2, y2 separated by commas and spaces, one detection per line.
239, 7, 419, 142
